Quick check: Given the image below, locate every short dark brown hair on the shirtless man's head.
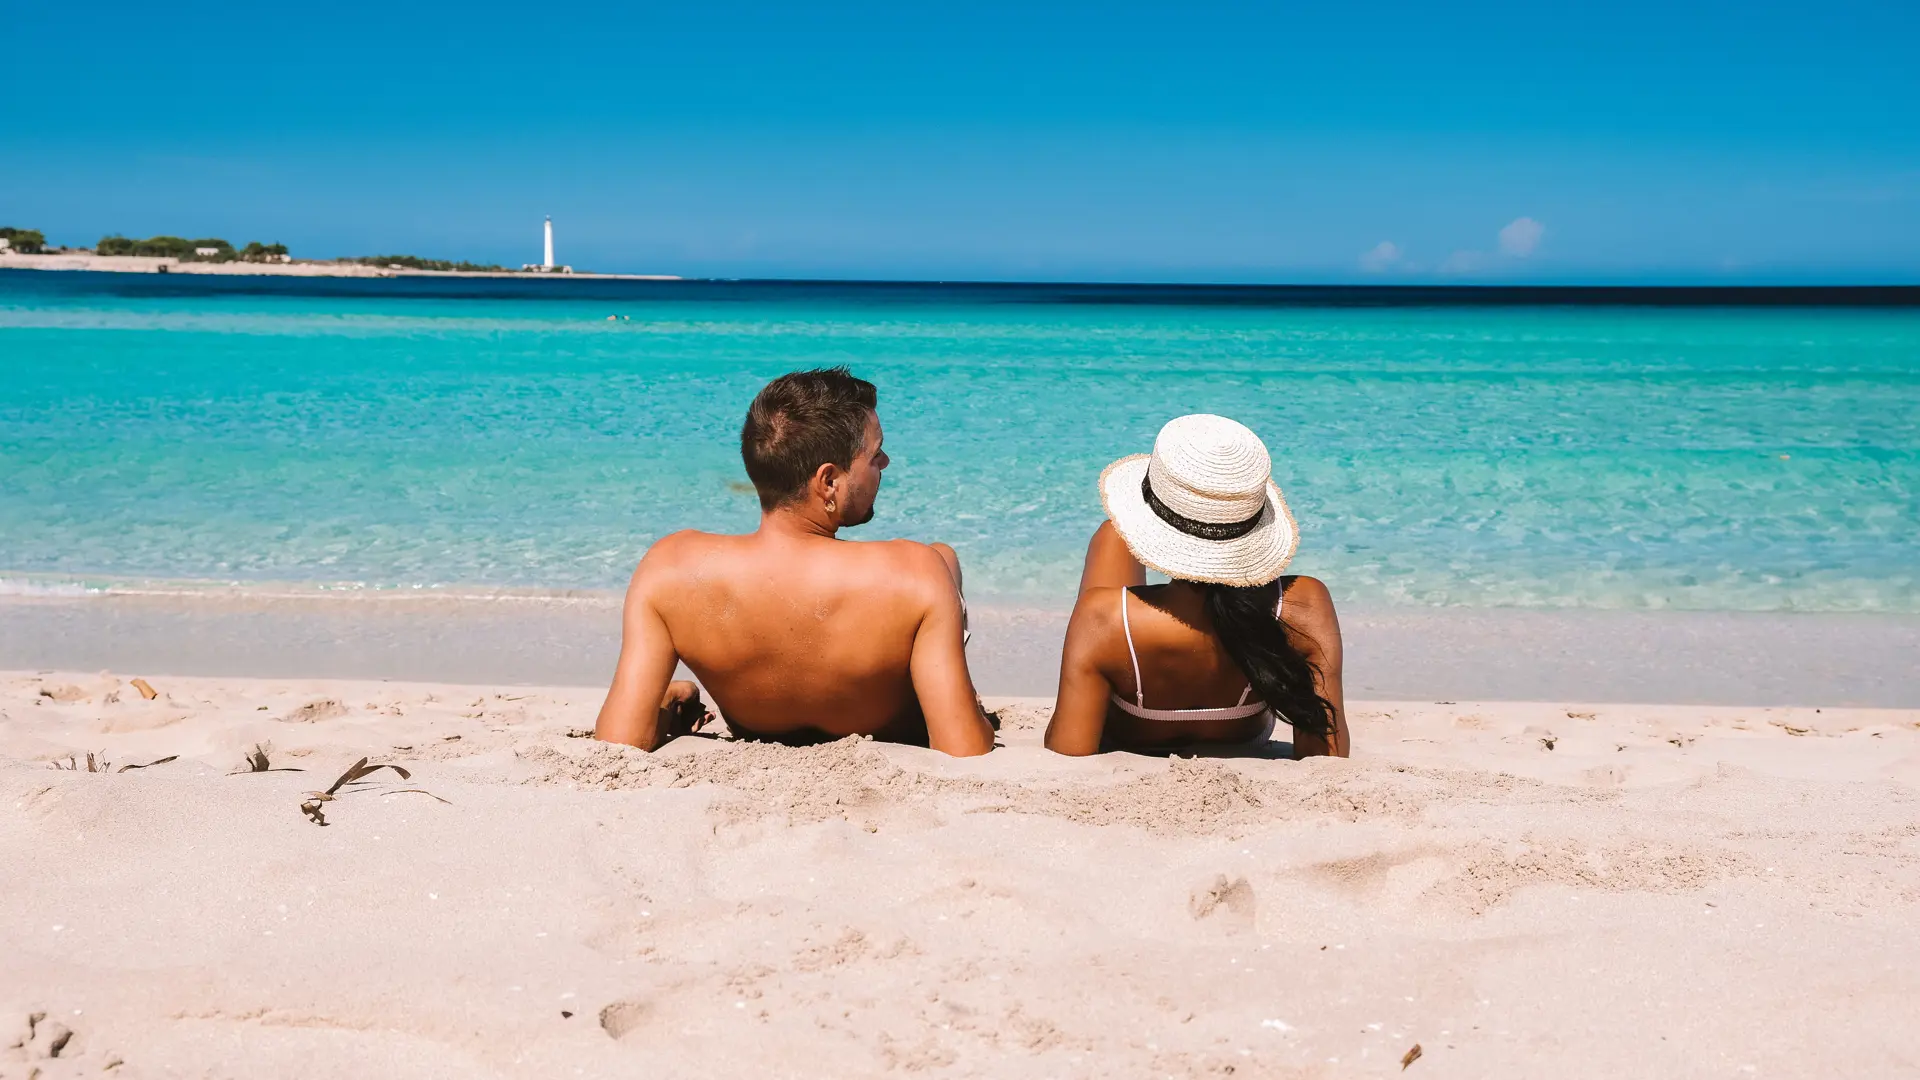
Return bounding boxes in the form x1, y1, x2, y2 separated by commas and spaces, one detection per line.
739, 367, 879, 509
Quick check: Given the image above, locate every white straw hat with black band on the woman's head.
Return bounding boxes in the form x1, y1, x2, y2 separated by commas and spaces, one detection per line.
1100, 413, 1300, 586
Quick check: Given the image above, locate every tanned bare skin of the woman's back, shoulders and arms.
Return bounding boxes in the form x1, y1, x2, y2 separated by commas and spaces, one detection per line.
1046, 523, 1348, 757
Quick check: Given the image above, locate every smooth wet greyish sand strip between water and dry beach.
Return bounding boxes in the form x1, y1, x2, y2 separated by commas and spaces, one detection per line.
0, 588, 1920, 707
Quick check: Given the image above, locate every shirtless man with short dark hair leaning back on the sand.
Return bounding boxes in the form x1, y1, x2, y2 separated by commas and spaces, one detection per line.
593, 367, 993, 755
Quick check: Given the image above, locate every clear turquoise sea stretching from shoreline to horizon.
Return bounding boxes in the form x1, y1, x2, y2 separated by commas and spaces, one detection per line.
0, 271, 1920, 613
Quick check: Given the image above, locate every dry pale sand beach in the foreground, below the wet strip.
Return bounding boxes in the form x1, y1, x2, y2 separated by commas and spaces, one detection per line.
0, 673, 1920, 1078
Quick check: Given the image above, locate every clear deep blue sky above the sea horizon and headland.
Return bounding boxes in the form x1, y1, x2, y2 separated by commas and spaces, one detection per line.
0, 0, 1920, 282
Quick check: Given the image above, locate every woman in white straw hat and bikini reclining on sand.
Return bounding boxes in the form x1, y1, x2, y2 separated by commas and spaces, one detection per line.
1046, 415, 1348, 757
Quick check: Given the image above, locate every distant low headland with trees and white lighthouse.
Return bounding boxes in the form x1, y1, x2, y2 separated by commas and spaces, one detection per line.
0, 219, 680, 281
